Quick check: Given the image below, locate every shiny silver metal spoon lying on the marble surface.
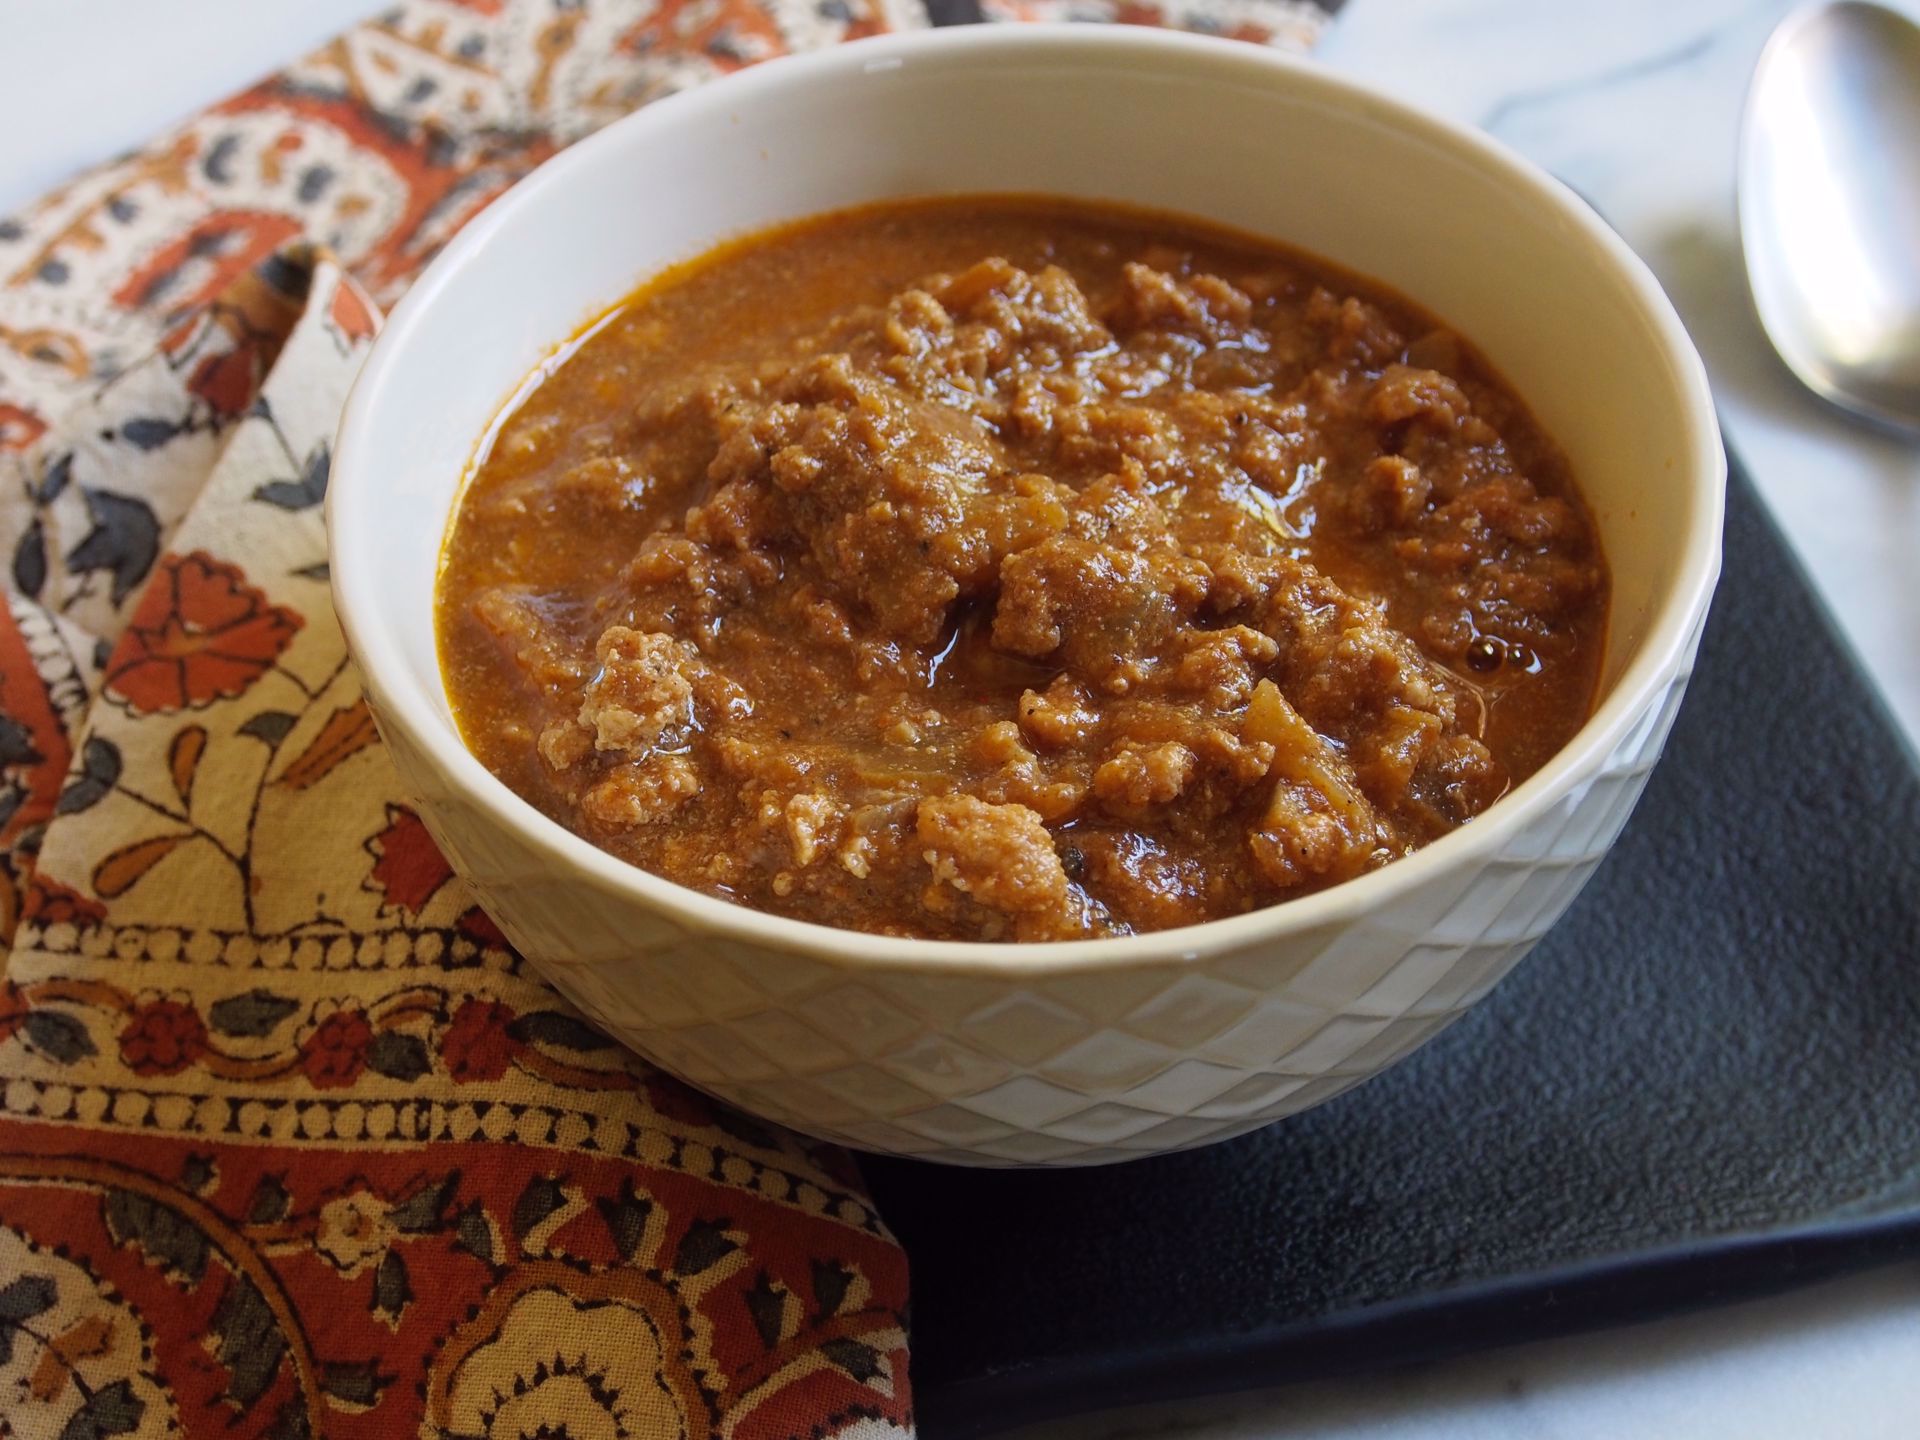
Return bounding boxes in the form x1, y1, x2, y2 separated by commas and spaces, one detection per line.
1740, 0, 1920, 432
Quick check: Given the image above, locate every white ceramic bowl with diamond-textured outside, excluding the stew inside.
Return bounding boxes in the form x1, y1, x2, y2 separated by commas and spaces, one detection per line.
330, 25, 1724, 1165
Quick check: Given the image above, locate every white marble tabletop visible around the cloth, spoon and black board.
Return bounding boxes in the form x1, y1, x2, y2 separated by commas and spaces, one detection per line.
0, 0, 1920, 1440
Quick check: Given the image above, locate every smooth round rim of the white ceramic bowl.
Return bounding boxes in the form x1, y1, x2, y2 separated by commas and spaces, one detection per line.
326, 23, 1726, 977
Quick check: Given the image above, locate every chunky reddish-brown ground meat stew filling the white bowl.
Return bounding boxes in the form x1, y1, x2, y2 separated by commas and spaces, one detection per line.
438, 198, 1609, 941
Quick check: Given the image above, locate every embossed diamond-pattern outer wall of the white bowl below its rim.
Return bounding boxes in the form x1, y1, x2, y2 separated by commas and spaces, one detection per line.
374, 636, 1697, 1165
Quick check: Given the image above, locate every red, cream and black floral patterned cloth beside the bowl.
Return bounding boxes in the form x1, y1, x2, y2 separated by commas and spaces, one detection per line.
0, 0, 1321, 1440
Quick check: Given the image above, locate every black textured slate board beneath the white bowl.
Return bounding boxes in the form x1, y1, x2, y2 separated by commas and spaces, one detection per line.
862, 453, 1920, 1440
